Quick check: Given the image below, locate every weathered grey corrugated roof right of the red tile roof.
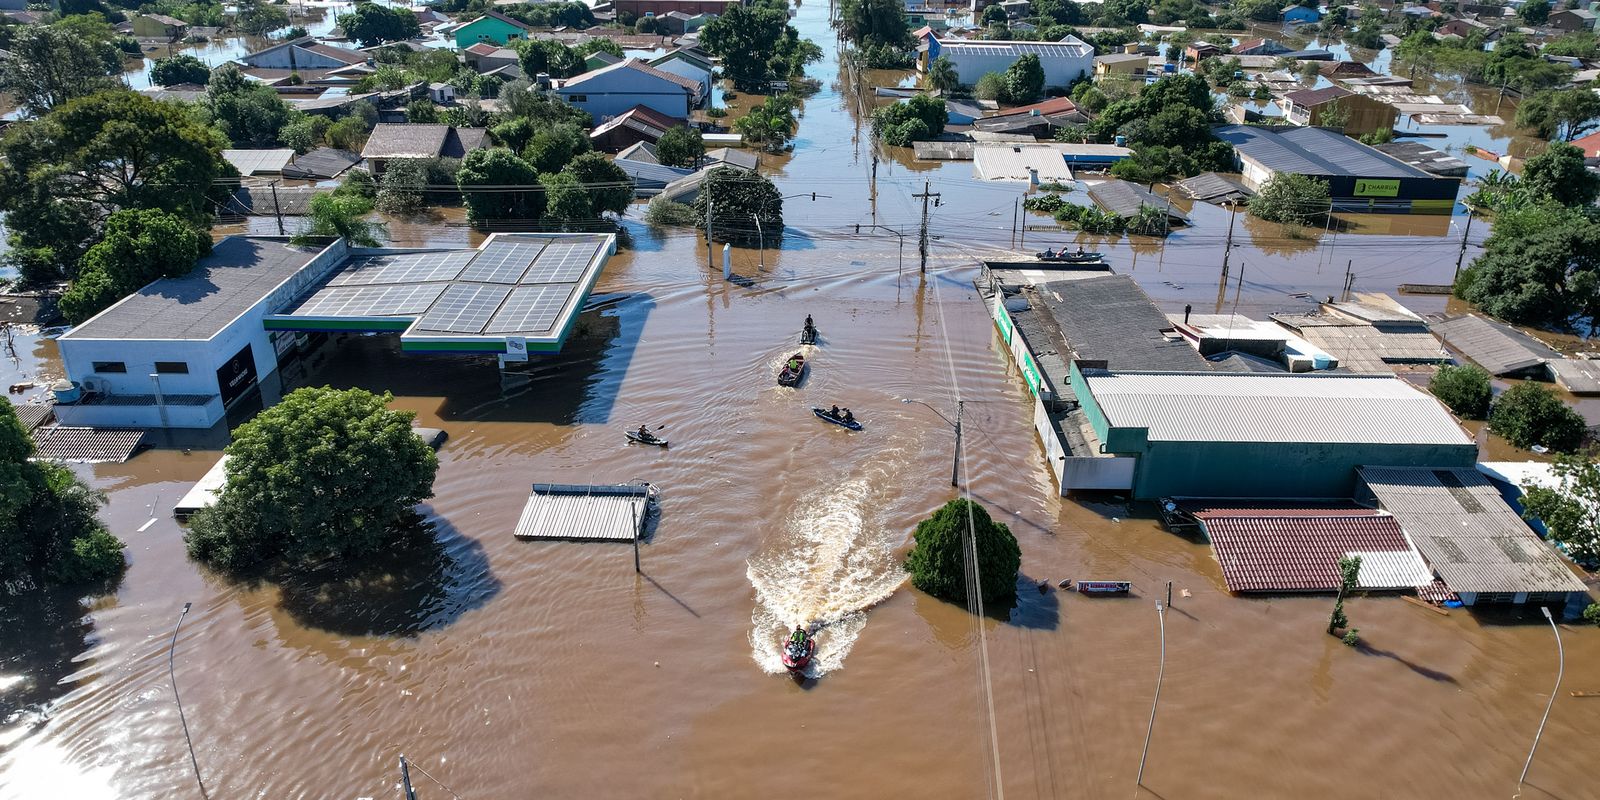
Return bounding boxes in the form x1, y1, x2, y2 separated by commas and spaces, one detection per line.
1357, 467, 1586, 594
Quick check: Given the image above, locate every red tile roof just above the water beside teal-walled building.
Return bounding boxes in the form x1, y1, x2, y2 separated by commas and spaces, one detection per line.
1192, 502, 1413, 592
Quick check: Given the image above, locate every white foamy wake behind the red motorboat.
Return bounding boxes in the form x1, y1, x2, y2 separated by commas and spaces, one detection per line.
747, 475, 906, 677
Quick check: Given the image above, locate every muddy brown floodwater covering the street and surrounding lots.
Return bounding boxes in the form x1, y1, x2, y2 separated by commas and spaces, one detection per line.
0, 3, 1600, 800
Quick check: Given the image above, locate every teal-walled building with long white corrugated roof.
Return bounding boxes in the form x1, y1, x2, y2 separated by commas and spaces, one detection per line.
1070, 360, 1478, 499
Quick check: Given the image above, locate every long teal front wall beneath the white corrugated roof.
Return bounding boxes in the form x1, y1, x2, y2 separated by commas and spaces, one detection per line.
1133, 442, 1478, 499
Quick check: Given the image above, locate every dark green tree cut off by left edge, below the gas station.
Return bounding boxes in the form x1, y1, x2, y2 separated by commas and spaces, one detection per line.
0, 403, 125, 587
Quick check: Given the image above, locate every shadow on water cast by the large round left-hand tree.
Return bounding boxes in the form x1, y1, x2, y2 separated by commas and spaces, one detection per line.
280, 517, 501, 637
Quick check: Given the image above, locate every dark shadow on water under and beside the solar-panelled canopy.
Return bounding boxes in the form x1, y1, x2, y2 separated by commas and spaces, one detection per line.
298, 294, 654, 426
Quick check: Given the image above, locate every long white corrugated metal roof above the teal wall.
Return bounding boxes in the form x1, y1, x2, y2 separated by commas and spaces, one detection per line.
1083, 370, 1474, 446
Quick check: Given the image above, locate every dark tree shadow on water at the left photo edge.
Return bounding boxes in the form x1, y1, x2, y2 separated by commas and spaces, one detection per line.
0, 587, 94, 736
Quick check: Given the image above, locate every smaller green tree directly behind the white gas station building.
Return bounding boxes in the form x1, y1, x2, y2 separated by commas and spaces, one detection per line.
61, 208, 211, 325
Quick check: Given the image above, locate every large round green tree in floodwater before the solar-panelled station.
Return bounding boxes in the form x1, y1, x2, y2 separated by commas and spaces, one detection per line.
184, 387, 438, 571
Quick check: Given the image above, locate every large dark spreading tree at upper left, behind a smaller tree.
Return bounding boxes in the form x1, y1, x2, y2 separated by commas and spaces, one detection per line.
0, 90, 226, 282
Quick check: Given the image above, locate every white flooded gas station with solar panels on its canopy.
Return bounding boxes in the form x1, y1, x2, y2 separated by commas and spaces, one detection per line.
54, 234, 616, 429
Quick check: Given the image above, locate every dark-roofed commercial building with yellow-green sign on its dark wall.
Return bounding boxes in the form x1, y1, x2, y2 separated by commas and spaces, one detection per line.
1213, 125, 1461, 214
